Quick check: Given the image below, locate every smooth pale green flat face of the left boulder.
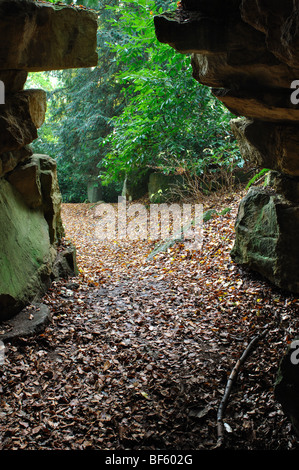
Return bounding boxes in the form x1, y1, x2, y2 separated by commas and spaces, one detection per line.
0, 178, 56, 321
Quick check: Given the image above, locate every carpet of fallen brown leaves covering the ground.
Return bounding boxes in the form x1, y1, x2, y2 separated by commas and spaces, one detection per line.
0, 189, 299, 450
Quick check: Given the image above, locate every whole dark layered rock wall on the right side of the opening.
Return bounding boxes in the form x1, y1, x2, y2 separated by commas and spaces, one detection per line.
155, 0, 299, 434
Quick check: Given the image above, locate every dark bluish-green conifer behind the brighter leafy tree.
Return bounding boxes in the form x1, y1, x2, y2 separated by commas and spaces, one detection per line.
29, 0, 123, 202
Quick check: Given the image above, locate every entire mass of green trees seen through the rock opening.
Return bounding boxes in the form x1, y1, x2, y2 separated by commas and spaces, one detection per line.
29, 0, 242, 202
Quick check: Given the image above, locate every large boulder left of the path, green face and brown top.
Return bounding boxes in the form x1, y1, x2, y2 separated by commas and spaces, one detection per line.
0, 154, 78, 321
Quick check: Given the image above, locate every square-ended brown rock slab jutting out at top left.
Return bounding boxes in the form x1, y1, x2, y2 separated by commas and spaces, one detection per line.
0, 0, 97, 71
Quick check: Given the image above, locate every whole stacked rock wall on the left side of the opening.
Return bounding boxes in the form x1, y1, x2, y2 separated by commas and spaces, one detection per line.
0, 0, 97, 321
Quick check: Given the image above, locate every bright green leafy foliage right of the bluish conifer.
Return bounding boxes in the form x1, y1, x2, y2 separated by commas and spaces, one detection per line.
101, 0, 241, 187
